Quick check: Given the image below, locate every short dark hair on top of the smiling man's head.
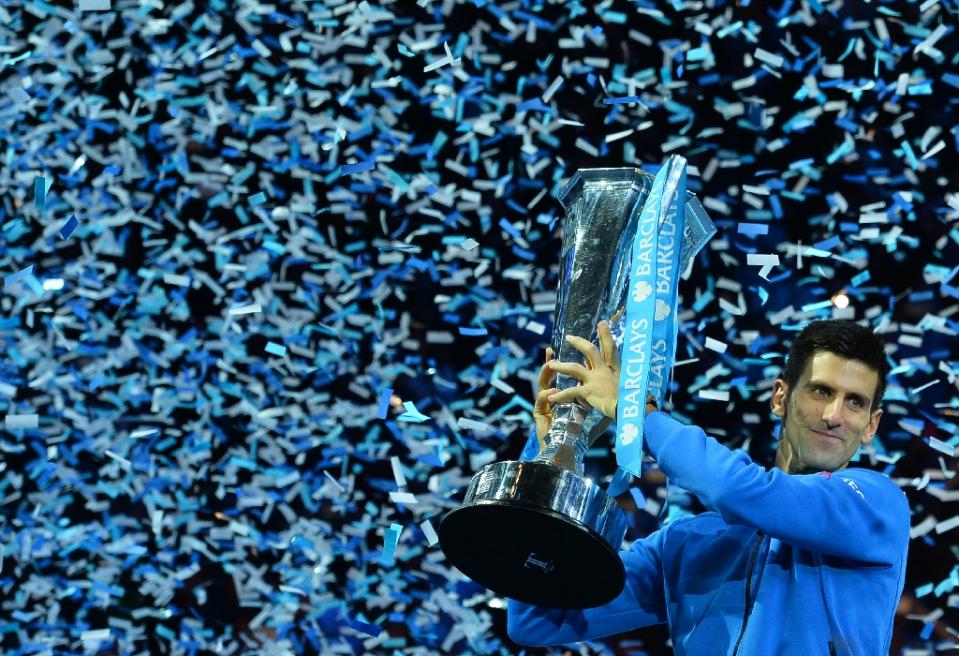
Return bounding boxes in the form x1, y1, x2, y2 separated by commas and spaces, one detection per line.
783, 319, 889, 410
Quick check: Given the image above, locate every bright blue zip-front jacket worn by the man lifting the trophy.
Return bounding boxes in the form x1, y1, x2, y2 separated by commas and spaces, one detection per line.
507, 412, 909, 656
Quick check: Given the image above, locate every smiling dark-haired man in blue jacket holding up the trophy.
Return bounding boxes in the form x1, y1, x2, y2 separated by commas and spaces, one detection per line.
507, 321, 909, 656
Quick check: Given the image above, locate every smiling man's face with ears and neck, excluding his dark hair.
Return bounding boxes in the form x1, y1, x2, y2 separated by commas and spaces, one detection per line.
771, 351, 882, 473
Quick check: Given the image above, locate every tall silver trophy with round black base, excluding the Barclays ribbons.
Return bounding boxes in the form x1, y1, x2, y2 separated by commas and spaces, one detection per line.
439, 168, 715, 608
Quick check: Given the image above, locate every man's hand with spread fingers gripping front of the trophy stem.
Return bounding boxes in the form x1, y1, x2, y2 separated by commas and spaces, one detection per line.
536, 321, 620, 420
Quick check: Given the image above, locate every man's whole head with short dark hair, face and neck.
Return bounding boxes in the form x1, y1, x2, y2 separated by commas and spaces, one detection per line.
771, 320, 889, 473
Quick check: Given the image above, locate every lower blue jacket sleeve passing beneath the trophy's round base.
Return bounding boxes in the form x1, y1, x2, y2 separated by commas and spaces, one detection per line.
506, 524, 673, 647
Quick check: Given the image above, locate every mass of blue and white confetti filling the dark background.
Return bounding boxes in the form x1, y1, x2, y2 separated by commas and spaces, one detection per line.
0, 0, 959, 656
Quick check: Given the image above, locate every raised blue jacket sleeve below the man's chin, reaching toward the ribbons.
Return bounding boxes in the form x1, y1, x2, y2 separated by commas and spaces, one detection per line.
643, 412, 909, 565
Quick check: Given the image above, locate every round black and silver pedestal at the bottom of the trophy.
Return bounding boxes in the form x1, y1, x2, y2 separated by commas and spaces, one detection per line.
439, 461, 626, 608
